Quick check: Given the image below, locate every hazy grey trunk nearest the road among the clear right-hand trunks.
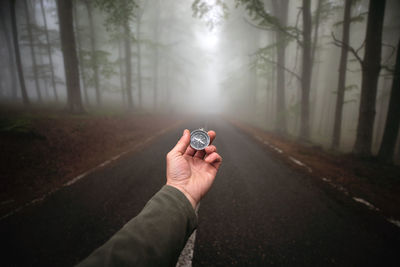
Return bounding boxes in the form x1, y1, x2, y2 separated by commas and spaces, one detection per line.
272, 0, 289, 135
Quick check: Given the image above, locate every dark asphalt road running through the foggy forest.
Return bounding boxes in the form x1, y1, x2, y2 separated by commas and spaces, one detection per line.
0, 120, 400, 266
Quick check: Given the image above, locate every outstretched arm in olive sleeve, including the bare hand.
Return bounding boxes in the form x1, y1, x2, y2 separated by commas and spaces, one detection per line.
78, 130, 222, 267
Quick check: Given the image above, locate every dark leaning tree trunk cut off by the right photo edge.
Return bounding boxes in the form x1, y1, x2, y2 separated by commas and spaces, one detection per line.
378, 37, 400, 163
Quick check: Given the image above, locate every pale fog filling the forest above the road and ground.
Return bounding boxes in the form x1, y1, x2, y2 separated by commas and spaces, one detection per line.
0, 0, 400, 159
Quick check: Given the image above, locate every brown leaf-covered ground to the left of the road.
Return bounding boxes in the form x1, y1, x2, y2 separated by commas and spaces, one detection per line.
0, 110, 180, 217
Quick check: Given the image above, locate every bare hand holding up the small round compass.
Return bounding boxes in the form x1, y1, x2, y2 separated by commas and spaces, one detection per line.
167, 130, 222, 208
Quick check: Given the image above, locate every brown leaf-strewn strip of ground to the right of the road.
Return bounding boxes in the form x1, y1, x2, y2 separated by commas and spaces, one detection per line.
231, 120, 400, 226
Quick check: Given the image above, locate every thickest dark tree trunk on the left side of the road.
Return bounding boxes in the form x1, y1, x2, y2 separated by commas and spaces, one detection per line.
57, 0, 83, 113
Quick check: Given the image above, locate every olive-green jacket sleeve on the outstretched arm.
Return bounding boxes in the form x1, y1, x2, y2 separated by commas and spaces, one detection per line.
78, 185, 197, 267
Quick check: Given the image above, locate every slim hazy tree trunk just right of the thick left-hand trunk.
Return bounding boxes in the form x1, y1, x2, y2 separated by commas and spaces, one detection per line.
84, 0, 101, 105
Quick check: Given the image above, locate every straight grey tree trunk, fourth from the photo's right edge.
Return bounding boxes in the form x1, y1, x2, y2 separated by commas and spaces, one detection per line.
299, 0, 312, 141
